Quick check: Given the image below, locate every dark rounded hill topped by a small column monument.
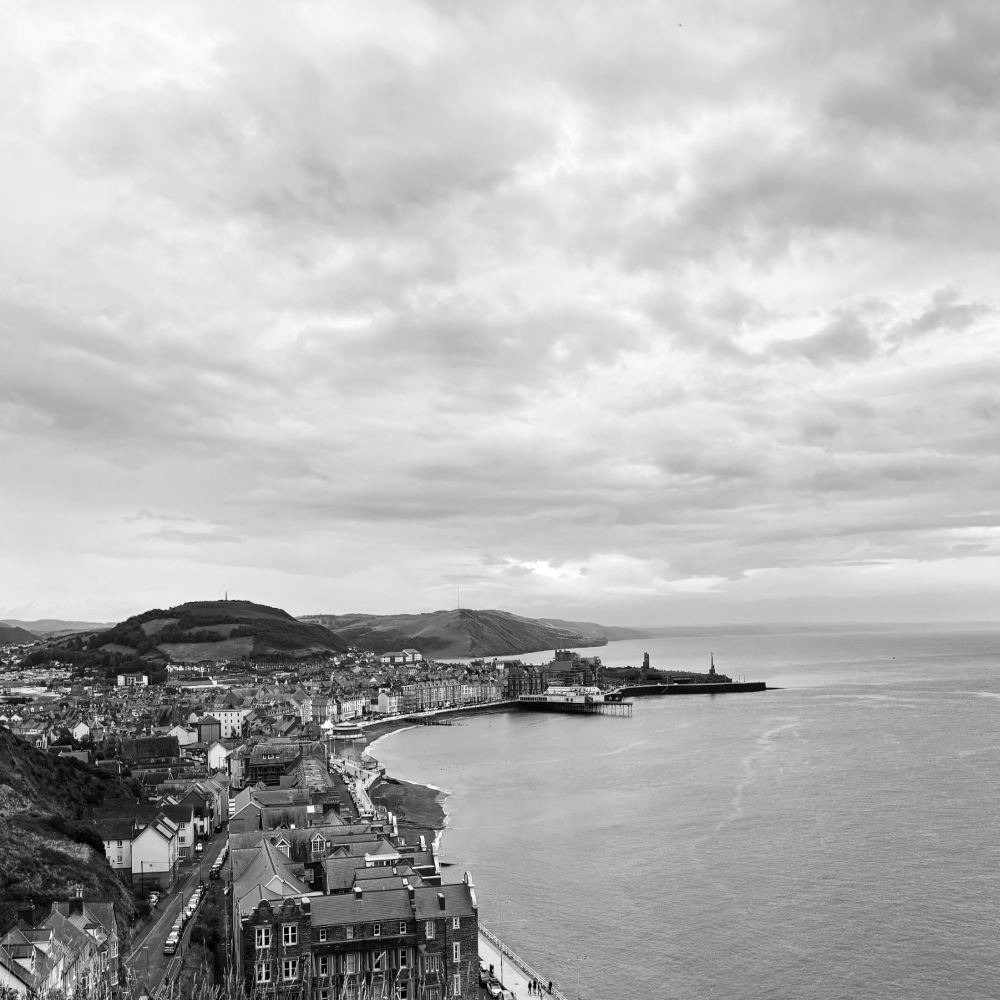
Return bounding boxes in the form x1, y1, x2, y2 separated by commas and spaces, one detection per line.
90, 601, 347, 662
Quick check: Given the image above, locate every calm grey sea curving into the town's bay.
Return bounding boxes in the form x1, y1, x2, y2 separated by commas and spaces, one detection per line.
374, 625, 1000, 1000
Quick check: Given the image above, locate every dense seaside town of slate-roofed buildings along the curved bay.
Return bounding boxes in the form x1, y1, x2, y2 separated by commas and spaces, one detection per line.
0, 624, 603, 1000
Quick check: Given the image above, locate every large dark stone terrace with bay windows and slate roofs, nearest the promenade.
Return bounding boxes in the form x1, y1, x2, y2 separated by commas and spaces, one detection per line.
226, 796, 479, 1000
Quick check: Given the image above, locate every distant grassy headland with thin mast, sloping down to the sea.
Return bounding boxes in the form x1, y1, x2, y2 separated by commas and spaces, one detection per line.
305, 608, 607, 657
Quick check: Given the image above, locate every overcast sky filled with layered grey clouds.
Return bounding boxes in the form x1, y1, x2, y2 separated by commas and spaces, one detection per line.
0, 0, 1000, 625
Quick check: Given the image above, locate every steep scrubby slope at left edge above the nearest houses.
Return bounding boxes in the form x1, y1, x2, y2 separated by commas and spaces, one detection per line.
0, 728, 135, 934
